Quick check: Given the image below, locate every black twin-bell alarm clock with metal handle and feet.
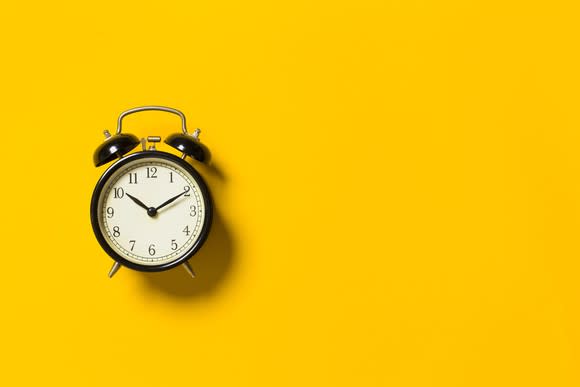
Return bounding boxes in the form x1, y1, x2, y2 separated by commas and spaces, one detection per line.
90, 106, 213, 277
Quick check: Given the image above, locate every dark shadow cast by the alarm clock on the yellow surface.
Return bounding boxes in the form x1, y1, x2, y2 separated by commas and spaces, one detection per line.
142, 208, 234, 300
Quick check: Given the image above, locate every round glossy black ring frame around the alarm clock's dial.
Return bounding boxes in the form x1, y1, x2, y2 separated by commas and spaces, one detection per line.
91, 150, 213, 272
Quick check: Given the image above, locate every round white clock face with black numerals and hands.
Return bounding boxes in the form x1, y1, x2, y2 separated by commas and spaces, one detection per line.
98, 156, 206, 266
